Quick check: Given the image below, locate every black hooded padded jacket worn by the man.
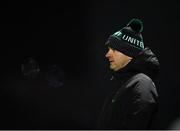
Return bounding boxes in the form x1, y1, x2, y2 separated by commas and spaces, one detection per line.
98, 48, 159, 129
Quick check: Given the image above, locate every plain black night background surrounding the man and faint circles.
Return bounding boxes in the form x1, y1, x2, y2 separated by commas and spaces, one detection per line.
0, 0, 180, 129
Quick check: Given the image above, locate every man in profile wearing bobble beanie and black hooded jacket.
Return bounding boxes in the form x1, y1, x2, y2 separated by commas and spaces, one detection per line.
98, 19, 159, 129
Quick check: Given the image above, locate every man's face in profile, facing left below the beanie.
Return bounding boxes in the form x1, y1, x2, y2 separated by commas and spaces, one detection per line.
106, 47, 132, 71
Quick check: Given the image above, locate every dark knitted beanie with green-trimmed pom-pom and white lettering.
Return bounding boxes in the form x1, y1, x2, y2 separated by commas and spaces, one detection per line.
106, 19, 144, 57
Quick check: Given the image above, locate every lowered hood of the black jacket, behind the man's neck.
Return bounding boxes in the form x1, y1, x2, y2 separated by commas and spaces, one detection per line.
114, 47, 160, 79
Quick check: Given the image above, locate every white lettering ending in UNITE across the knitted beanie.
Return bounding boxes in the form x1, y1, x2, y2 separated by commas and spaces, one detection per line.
114, 31, 144, 49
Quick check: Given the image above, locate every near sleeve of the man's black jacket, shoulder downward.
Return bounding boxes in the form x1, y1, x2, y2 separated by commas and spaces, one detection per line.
116, 77, 157, 129
